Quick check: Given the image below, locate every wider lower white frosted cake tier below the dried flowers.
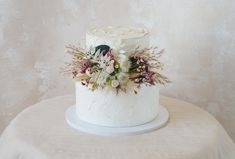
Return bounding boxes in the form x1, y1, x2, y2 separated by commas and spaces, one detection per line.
76, 82, 159, 127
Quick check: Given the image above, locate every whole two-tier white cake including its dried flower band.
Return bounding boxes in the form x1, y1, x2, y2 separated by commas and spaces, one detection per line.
64, 26, 168, 127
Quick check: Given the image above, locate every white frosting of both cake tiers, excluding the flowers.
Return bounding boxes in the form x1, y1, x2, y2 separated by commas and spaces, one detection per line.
76, 27, 159, 127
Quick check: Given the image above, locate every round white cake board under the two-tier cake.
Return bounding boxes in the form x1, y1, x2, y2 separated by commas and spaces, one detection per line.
65, 105, 169, 136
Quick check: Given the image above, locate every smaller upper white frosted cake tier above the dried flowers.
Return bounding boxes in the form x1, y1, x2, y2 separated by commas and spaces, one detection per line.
86, 26, 149, 51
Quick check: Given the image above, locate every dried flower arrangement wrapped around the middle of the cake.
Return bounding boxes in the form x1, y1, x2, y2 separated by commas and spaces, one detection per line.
64, 45, 170, 93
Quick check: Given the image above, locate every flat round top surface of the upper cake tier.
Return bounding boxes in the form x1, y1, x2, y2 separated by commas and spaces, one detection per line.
87, 26, 148, 39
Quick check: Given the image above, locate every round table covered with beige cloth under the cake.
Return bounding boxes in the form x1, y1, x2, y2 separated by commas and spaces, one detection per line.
0, 95, 235, 159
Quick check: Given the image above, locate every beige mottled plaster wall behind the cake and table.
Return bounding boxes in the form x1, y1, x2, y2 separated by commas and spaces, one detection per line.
0, 0, 235, 140
